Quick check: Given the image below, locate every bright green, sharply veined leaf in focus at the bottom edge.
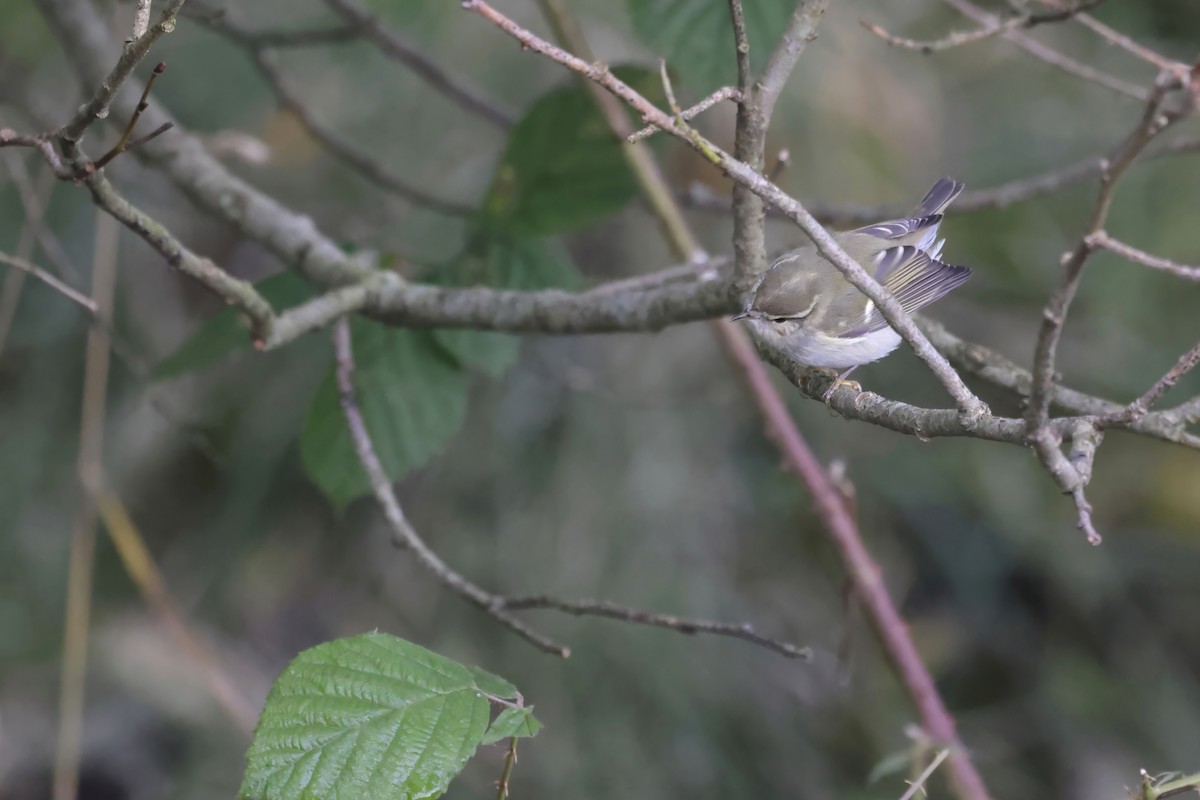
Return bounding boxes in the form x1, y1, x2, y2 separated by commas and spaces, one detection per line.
238, 632, 530, 800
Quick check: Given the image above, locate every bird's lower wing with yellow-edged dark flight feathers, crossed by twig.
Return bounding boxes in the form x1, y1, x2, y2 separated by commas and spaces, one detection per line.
830, 246, 971, 338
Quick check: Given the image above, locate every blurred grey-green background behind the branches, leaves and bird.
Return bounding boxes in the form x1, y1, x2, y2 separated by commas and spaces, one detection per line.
0, 0, 1200, 800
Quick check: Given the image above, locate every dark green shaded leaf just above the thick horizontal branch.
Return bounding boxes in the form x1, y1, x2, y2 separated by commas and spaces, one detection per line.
482, 67, 656, 236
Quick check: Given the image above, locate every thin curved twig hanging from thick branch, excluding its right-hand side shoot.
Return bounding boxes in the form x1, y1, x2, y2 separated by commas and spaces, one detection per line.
334, 319, 571, 658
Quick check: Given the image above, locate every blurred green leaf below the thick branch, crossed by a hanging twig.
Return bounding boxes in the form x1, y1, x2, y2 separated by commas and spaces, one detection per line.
300, 319, 467, 509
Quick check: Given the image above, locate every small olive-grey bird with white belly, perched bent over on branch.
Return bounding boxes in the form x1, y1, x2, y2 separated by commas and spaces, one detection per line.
733, 178, 971, 403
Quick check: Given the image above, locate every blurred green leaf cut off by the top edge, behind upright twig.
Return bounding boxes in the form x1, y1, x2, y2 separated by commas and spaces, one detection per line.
625, 0, 796, 90
